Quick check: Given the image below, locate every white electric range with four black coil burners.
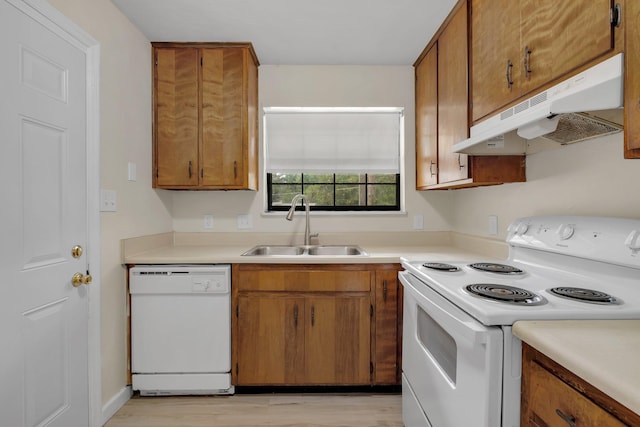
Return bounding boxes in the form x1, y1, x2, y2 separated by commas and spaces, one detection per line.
399, 216, 640, 427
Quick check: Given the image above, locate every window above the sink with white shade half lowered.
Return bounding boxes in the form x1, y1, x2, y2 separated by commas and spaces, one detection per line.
264, 107, 404, 211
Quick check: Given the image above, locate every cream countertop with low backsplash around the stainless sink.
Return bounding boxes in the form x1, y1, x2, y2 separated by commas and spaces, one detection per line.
121, 232, 508, 264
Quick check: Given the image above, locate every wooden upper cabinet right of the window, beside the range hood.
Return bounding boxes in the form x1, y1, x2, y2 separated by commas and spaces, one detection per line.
414, 0, 526, 190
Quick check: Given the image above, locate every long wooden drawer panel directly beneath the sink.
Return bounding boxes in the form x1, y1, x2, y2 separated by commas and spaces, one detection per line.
234, 269, 371, 292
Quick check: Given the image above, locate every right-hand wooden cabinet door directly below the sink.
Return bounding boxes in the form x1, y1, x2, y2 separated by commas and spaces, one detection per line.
305, 295, 371, 385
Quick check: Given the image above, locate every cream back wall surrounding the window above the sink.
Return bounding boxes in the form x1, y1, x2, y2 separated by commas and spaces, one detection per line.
173, 65, 451, 236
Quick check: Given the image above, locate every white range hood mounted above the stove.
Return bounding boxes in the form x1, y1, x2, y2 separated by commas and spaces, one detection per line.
453, 53, 623, 155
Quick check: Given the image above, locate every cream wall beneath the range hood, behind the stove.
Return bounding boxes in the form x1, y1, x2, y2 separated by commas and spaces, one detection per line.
452, 133, 640, 239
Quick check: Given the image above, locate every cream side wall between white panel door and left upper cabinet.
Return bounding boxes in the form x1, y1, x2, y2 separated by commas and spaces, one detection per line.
50, 0, 172, 410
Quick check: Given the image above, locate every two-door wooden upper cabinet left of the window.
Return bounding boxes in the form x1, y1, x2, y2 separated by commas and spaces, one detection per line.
152, 43, 259, 190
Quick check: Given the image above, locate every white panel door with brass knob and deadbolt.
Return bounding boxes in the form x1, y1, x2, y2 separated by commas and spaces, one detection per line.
0, 0, 89, 427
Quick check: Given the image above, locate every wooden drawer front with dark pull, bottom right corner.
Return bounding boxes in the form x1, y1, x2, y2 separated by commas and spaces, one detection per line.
523, 363, 625, 427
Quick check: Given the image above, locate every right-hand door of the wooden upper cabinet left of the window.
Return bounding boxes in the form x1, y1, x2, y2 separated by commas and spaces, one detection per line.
200, 48, 246, 187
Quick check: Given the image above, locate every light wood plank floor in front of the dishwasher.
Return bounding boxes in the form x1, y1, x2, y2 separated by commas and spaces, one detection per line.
105, 393, 403, 427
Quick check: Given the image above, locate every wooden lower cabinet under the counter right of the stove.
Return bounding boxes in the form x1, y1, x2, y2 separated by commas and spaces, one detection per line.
521, 344, 640, 427
